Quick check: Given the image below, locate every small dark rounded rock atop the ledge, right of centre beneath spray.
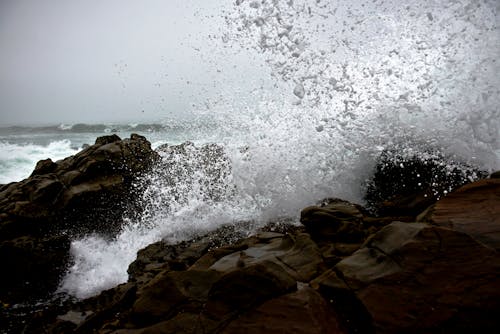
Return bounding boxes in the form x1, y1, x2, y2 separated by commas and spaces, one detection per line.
300, 199, 365, 242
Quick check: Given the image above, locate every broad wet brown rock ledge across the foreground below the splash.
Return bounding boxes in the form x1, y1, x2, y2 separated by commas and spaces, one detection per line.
2, 134, 500, 334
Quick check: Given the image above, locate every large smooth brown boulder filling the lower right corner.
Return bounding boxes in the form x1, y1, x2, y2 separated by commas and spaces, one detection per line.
335, 222, 500, 333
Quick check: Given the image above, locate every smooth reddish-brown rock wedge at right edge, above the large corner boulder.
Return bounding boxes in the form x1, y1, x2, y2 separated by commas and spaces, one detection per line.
420, 178, 500, 250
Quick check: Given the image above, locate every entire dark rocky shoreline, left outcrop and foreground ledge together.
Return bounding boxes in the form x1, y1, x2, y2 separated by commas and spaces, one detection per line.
0, 135, 500, 333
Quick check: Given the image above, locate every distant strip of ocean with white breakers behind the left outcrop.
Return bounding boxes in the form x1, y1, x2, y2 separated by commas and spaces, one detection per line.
0, 123, 220, 184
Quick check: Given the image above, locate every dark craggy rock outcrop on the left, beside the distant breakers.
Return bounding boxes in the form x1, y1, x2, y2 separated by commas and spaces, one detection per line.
0, 135, 158, 304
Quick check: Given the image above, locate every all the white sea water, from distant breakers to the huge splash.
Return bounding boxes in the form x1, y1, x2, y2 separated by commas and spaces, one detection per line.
0, 0, 500, 298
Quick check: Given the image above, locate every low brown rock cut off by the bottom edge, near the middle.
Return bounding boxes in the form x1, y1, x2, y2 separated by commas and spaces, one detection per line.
221, 287, 348, 334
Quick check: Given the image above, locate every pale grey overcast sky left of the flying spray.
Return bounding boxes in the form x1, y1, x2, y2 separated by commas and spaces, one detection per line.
0, 0, 265, 125
